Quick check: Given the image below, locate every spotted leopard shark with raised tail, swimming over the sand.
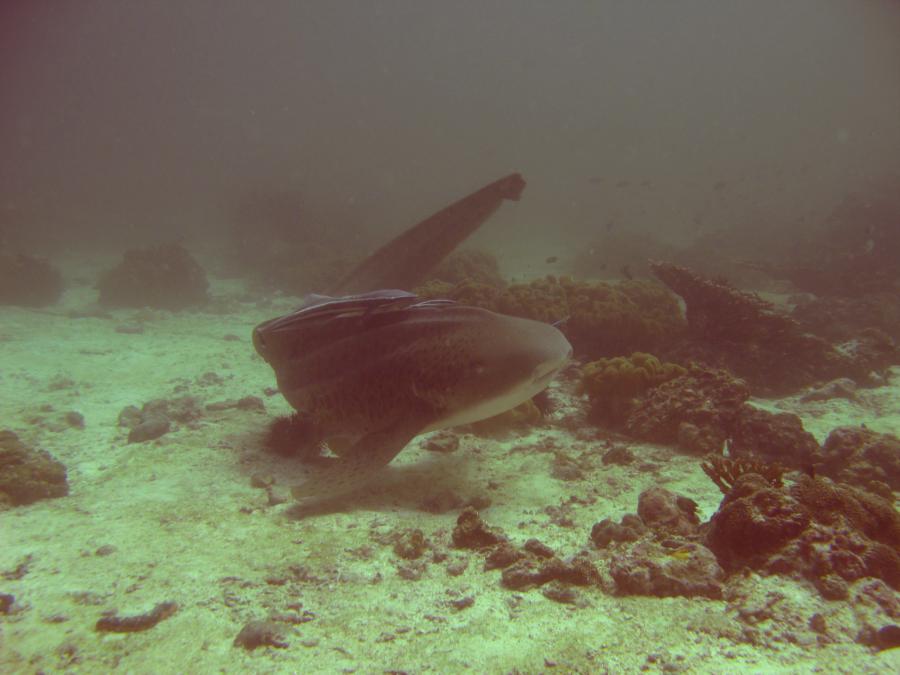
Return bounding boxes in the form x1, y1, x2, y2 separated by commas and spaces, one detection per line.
253, 174, 572, 501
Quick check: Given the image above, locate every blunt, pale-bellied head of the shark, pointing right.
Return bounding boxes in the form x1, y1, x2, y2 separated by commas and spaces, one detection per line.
430, 307, 572, 429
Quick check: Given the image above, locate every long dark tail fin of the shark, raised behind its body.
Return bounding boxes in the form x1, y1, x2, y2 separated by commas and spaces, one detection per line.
329, 173, 525, 295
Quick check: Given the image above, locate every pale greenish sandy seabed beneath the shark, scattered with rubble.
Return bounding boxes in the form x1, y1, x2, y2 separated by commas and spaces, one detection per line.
0, 270, 900, 673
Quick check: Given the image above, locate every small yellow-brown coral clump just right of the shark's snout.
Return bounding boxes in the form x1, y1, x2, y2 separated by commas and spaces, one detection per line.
581, 352, 687, 427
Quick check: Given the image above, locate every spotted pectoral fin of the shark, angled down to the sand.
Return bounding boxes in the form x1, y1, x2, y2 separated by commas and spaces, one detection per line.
291, 422, 424, 501
